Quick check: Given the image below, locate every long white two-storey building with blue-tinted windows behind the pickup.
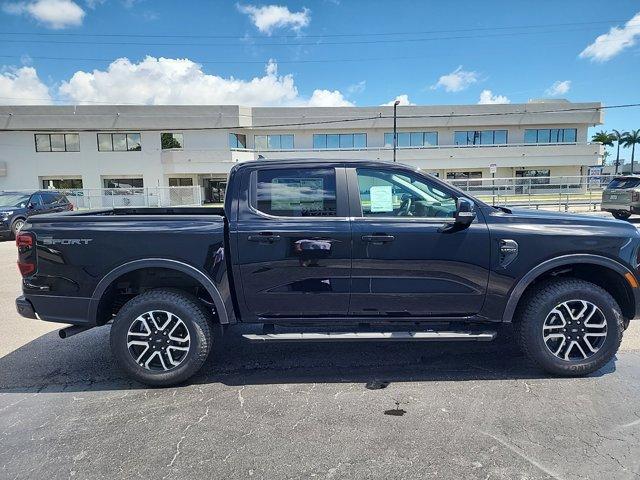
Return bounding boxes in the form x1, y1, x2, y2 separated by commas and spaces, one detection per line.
0, 101, 603, 201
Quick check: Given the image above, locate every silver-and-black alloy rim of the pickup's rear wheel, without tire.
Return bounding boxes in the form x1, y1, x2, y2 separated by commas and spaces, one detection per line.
127, 310, 191, 372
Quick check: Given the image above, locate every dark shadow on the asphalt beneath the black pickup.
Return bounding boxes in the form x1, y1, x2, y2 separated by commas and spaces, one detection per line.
0, 326, 615, 393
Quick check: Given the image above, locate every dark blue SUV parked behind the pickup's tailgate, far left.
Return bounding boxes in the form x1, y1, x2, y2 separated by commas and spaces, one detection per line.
0, 190, 73, 237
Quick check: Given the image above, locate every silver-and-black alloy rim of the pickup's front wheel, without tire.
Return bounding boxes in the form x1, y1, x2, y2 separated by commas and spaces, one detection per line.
542, 300, 607, 361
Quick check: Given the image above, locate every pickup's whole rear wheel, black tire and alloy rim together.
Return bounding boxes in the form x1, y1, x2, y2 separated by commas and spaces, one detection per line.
110, 290, 212, 386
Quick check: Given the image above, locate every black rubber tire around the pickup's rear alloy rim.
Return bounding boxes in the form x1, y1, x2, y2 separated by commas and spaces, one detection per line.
110, 289, 213, 387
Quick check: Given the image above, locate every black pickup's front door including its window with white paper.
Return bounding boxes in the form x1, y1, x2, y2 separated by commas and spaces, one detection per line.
347, 167, 490, 318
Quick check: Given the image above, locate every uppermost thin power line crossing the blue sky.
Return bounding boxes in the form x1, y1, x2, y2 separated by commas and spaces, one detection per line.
0, 20, 625, 40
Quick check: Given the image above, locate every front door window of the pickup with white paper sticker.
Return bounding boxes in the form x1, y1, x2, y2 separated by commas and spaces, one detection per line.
357, 168, 456, 218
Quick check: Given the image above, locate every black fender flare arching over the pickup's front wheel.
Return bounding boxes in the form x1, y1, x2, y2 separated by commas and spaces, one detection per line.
502, 254, 637, 323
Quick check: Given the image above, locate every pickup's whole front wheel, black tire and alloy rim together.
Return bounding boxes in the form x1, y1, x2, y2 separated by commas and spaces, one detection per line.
515, 278, 624, 376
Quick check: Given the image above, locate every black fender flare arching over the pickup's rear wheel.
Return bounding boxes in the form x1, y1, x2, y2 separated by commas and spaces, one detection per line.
88, 258, 229, 324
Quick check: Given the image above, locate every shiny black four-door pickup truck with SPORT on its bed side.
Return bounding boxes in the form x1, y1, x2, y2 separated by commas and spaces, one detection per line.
16, 160, 640, 385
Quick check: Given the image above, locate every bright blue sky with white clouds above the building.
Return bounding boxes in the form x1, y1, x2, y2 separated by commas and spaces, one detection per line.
0, 0, 640, 135
